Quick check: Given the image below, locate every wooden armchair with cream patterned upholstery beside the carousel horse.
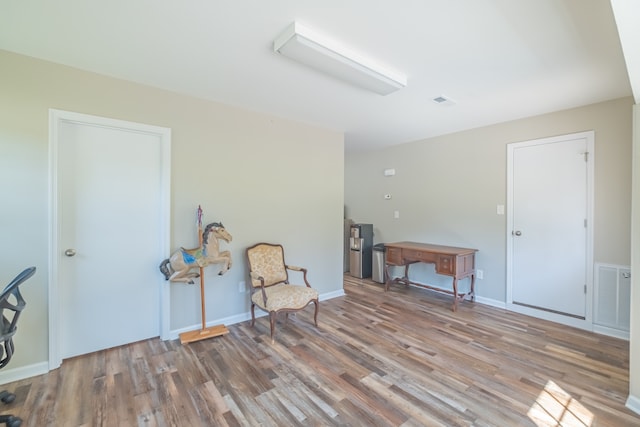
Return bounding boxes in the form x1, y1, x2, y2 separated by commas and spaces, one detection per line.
247, 243, 319, 342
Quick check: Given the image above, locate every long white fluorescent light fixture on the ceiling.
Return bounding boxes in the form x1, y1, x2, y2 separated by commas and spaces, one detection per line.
273, 22, 407, 95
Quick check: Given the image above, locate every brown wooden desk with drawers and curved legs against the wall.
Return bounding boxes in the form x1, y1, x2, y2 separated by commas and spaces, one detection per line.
384, 242, 478, 311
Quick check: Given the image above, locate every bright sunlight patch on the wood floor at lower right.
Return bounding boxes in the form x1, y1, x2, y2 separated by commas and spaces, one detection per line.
527, 380, 594, 427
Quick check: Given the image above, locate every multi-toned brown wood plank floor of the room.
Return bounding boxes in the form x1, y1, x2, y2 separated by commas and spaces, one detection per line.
2, 276, 640, 427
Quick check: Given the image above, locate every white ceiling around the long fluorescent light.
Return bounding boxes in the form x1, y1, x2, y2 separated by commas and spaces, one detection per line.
0, 0, 640, 150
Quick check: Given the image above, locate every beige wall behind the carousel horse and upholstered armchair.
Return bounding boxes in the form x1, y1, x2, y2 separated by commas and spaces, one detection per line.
0, 51, 344, 374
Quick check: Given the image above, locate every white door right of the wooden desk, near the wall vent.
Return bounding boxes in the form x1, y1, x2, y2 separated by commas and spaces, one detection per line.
508, 132, 593, 319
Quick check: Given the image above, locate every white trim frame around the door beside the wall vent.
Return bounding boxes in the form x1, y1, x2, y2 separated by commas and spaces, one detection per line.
505, 130, 595, 330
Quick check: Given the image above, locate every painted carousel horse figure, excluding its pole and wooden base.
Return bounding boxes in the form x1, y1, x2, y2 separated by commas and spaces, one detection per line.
160, 222, 233, 284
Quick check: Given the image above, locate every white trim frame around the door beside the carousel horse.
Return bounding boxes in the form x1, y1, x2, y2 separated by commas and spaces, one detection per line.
48, 109, 171, 371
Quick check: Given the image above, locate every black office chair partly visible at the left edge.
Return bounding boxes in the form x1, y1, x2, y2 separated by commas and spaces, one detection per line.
0, 267, 36, 427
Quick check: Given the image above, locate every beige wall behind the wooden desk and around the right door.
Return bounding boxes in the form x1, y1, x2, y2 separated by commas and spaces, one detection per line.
345, 98, 632, 302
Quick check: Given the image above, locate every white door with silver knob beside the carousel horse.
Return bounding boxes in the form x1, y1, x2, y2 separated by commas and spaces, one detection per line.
52, 113, 168, 360
